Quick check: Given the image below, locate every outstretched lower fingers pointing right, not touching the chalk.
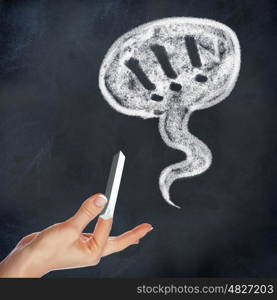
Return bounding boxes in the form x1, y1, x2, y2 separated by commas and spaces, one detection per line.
102, 223, 153, 256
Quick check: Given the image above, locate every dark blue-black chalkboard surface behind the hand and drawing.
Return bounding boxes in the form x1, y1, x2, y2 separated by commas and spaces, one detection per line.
0, 0, 277, 278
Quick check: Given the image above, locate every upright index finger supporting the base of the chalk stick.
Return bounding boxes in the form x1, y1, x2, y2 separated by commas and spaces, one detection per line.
93, 217, 113, 253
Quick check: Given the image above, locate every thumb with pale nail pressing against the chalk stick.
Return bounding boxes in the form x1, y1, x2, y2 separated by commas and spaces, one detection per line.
67, 194, 107, 233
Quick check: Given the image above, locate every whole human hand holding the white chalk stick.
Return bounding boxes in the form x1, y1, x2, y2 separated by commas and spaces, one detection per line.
0, 194, 153, 278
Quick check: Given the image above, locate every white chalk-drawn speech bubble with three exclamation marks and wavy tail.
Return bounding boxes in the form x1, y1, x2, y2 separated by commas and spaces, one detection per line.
99, 17, 240, 206
